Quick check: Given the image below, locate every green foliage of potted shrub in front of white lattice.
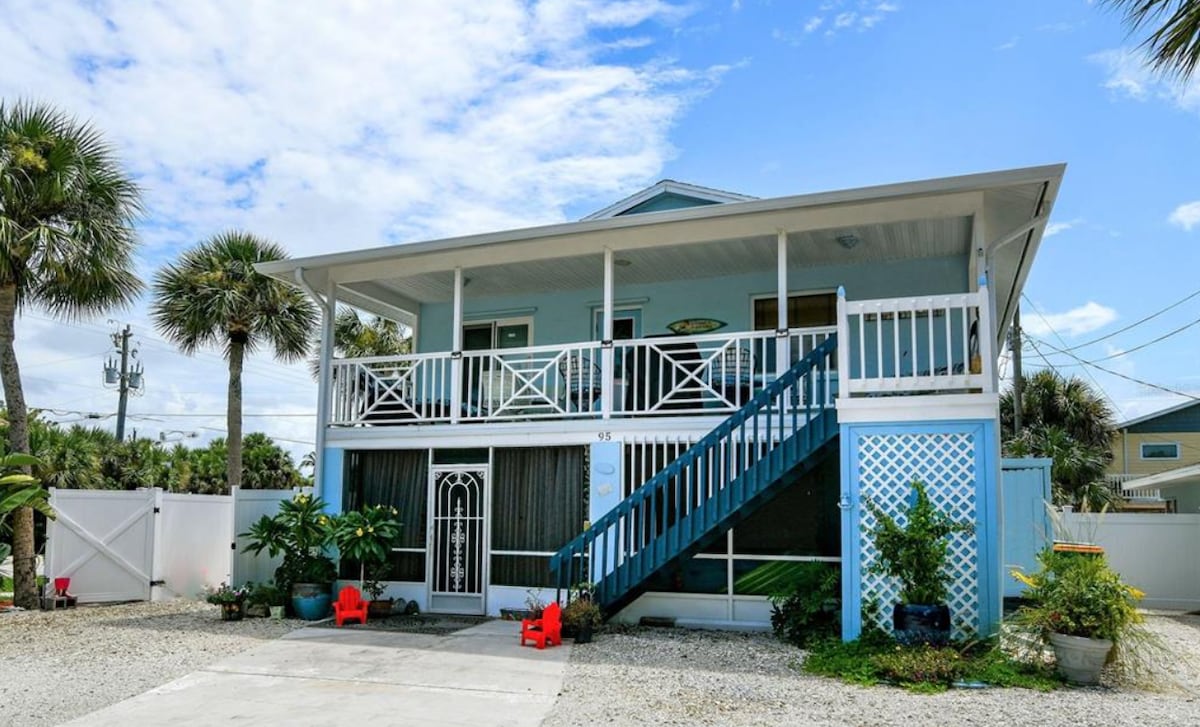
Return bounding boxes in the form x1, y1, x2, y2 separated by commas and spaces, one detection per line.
866, 482, 974, 606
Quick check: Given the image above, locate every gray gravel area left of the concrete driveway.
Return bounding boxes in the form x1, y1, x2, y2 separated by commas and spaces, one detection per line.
0, 601, 302, 727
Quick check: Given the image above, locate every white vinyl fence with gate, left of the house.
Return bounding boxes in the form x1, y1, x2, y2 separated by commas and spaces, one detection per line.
46, 487, 296, 603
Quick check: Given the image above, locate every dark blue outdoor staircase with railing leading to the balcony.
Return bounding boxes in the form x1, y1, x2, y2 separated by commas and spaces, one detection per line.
550, 336, 838, 615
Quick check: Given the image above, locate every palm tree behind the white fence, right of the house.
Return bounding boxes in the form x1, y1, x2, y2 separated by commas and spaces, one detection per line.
1000, 368, 1116, 510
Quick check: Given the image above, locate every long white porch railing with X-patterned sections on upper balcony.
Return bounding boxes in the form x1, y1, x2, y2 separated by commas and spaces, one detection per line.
330, 326, 838, 426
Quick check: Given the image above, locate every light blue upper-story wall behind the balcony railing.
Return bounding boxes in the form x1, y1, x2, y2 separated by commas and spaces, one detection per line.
416, 256, 968, 353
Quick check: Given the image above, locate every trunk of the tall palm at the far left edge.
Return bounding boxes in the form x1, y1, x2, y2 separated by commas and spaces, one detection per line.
0, 286, 37, 608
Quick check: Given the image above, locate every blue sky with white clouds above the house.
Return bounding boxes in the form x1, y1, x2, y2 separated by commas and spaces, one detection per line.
0, 0, 1200, 451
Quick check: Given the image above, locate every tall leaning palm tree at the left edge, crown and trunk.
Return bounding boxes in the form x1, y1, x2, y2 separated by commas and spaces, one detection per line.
0, 103, 142, 608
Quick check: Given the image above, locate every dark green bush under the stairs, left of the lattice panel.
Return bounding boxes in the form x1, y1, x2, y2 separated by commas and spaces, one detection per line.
770, 563, 841, 647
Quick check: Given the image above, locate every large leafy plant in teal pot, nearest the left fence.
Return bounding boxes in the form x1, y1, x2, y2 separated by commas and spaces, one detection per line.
239, 493, 337, 620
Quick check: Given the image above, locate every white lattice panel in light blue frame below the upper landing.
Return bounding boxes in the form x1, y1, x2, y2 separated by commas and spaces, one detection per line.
841, 419, 1001, 639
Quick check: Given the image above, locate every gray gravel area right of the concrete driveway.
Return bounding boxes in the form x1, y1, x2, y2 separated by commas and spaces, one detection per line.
544, 615, 1200, 727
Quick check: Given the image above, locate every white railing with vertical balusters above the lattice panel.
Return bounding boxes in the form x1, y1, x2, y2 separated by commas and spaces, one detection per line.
838, 287, 995, 396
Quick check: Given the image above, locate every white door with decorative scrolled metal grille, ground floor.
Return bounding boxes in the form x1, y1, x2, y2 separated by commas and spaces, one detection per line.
432, 468, 487, 596
